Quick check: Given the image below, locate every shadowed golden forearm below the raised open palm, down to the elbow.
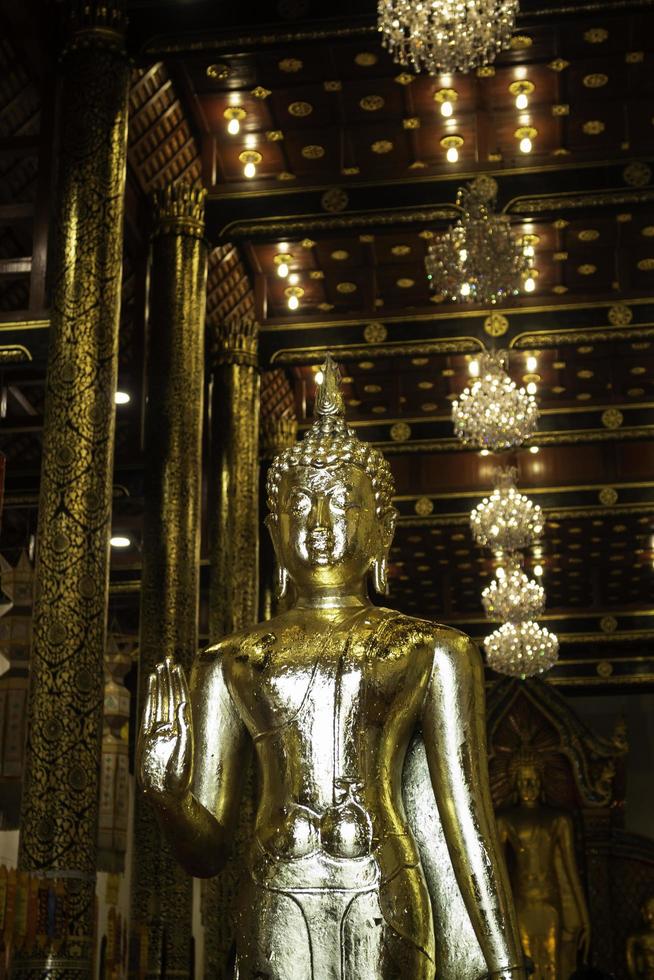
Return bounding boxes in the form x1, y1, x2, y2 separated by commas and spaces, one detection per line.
150, 790, 229, 878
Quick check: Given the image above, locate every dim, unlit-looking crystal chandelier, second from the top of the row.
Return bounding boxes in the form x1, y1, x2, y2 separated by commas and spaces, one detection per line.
425, 176, 535, 306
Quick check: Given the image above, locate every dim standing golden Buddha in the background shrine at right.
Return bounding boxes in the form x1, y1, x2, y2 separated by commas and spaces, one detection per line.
497, 751, 590, 980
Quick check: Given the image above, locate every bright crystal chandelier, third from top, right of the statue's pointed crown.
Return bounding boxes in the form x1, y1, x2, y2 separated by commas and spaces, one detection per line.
452, 351, 538, 450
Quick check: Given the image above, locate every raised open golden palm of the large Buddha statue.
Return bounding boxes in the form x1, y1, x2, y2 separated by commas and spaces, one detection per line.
137, 659, 193, 799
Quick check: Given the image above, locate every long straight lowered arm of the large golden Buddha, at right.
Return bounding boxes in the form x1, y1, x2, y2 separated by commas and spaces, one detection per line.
422, 633, 524, 978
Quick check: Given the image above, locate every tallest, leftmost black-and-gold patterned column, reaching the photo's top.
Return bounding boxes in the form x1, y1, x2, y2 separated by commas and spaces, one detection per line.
12, 0, 129, 980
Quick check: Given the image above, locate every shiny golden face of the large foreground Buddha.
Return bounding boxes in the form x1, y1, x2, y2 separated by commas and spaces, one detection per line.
269, 464, 392, 591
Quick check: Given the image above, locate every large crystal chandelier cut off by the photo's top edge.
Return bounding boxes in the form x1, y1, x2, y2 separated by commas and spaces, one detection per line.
377, 0, 518, 75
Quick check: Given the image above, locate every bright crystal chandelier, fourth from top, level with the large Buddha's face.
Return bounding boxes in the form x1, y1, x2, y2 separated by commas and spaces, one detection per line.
470, 466, 544, 551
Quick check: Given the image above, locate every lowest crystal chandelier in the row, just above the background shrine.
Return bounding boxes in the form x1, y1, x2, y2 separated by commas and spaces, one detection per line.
484, 620, 559, 677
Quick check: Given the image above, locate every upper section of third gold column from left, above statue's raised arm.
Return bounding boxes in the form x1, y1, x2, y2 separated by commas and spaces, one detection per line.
209, 319, 260, 643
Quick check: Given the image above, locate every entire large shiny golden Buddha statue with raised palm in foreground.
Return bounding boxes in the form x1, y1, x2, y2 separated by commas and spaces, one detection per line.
138, 356, 525, 980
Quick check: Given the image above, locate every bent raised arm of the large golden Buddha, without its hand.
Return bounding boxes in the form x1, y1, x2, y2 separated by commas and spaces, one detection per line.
148, 654, 250, 878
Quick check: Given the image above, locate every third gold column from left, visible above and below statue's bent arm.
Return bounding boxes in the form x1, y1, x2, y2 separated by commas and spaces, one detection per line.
203, 320, 260, 980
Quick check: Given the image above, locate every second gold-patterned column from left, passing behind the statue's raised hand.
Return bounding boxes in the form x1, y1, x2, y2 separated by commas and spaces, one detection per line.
132, 184, 207, 980
